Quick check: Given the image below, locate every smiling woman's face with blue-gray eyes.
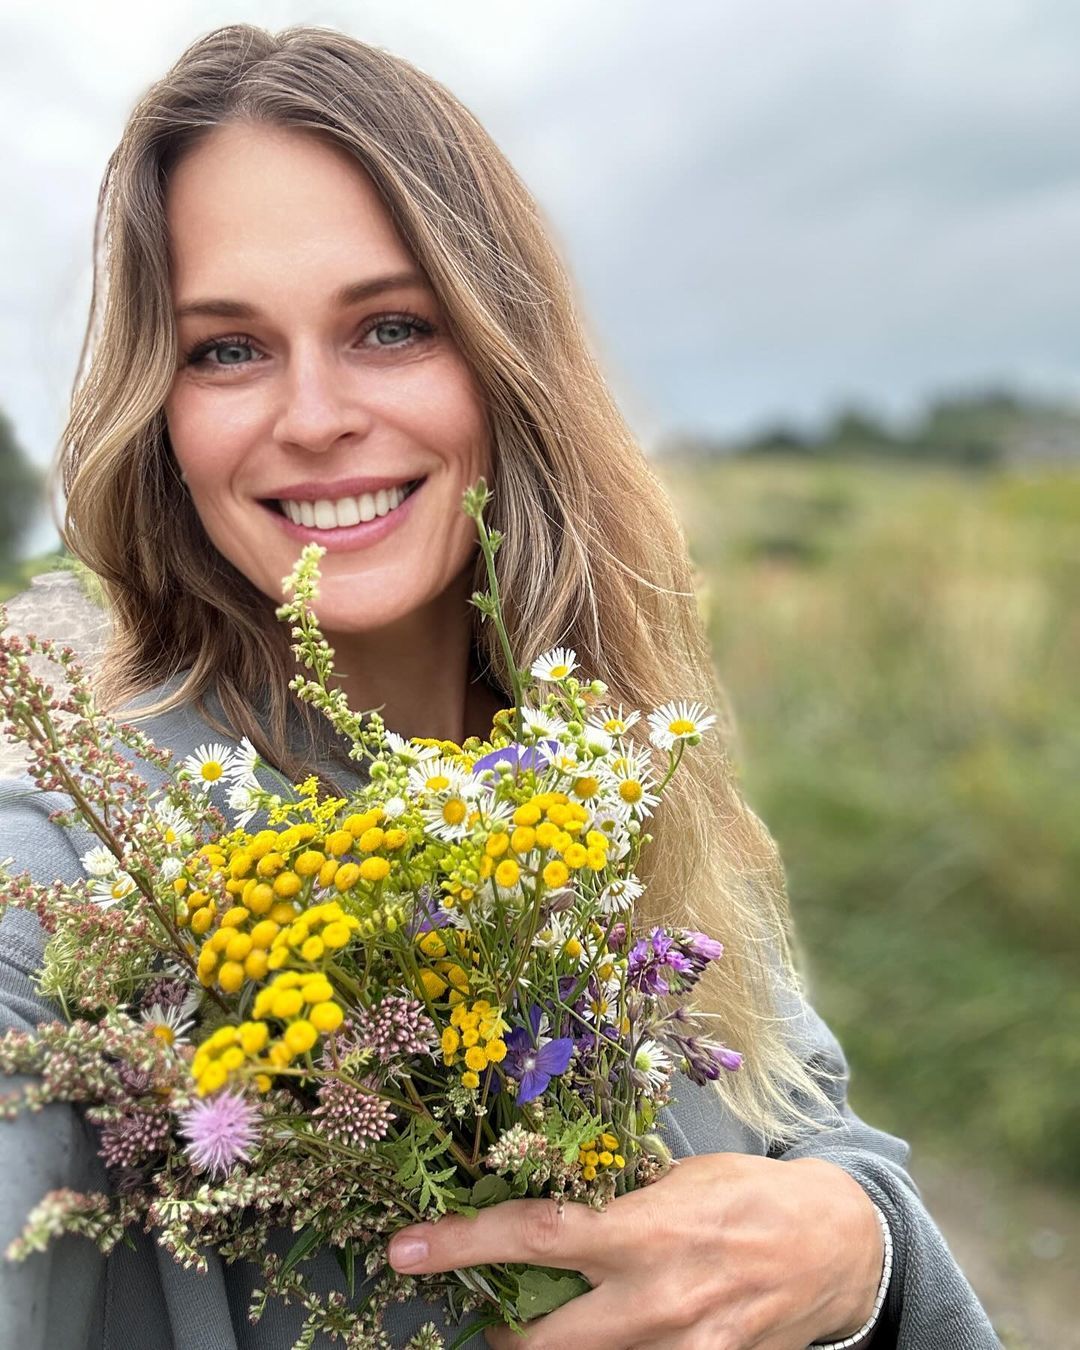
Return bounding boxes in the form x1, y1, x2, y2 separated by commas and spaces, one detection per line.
165, 118, 491, 633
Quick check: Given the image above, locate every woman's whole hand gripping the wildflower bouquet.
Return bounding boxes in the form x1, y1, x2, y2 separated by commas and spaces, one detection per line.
390, 1153, 884, 1350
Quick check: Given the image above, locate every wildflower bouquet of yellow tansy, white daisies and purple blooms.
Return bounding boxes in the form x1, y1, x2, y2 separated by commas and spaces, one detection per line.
0, 479, 741, 1346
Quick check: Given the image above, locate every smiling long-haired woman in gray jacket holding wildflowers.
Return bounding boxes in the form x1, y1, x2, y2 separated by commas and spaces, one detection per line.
0, 24, 998, 1350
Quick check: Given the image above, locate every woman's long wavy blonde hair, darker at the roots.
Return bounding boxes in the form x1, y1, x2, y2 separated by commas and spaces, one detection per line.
50, 23, 834, 1142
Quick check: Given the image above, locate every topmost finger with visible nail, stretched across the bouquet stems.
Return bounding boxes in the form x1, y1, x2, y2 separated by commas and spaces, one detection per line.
389, 1200, 625, 1279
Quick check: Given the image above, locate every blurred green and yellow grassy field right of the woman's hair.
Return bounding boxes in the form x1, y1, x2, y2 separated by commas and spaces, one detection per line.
657, 453, 1080, 1188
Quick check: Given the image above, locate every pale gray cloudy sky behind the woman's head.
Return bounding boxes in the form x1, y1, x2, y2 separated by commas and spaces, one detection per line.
0, 0, 1080, 548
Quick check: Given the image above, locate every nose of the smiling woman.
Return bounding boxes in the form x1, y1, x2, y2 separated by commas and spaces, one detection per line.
274, 339, 373, 454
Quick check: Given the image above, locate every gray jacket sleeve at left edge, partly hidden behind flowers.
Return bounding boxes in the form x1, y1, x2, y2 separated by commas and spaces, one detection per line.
0, 778, 107, 1350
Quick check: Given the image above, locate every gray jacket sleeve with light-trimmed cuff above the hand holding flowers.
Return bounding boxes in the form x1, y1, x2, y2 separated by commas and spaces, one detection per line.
767, 972, 1000, 1350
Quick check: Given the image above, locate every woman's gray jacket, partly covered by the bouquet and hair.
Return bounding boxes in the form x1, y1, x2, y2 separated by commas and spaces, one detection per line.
0, 686, 1000, 1350
